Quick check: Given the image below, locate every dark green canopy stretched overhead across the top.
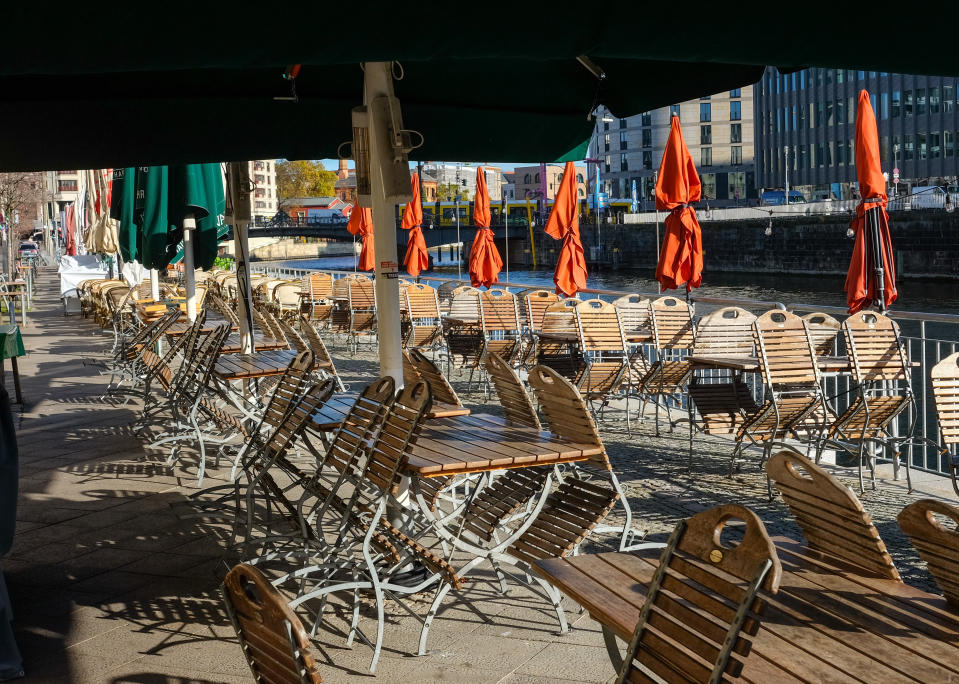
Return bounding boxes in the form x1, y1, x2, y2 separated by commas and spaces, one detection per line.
0, 8, 959, 170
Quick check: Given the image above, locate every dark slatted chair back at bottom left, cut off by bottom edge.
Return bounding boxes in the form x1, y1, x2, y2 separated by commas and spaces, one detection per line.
220, 564, 323, 684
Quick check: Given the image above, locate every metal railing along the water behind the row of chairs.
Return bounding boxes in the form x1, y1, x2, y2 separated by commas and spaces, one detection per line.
251, 264, 959, 475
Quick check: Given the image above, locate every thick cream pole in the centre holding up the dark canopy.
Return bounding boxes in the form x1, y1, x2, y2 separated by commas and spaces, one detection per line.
363, 62, 409, 387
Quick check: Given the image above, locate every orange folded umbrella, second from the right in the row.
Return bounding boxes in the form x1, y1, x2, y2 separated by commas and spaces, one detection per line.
656, 115, 703, 292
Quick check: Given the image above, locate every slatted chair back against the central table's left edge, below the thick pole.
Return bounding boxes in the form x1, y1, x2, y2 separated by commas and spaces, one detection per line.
363, 381, 431, 496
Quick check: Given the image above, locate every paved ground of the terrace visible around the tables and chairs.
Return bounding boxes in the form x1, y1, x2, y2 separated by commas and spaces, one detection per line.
3, 269, 946, 684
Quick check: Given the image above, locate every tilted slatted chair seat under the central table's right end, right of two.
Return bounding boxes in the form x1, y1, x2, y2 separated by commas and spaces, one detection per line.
509, 477, 619, 563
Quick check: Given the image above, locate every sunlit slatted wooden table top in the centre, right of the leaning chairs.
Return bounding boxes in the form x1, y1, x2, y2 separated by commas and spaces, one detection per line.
407, 413, 603, 477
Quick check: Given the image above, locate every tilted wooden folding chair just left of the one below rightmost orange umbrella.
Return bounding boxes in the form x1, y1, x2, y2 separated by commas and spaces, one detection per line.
729, 310, 824, 480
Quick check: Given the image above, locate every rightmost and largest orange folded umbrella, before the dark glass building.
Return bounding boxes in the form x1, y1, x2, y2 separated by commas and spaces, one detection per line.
846, 90, 898, 313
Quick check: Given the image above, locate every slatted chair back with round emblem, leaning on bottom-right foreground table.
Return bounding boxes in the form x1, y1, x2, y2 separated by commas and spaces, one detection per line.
616, 504, 782, 682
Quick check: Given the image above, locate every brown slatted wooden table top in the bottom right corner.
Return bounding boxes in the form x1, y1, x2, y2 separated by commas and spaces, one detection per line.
536, 537, 959, 684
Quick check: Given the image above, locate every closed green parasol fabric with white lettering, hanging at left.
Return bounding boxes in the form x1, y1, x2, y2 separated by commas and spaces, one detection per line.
135, 164, 226, 269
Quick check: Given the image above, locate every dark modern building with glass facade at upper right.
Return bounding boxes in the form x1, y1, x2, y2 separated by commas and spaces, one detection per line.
753, 67, 959, 200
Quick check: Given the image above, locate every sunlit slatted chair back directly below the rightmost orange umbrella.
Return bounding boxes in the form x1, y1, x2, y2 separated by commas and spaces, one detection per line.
852, 311, 910, 387
